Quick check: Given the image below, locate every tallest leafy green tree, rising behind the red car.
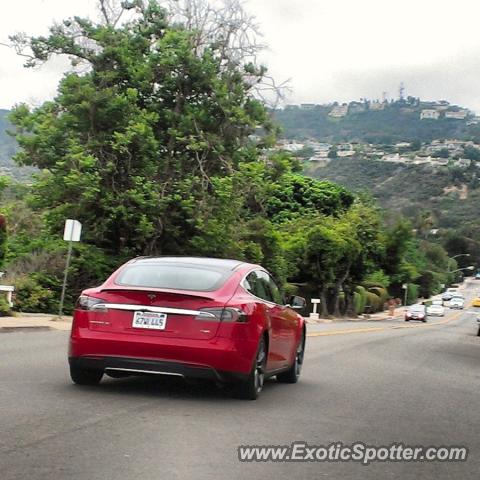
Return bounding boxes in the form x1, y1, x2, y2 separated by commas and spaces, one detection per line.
10, 1, 273, 255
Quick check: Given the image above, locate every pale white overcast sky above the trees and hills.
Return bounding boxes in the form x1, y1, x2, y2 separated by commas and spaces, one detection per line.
0, 0, 480, 113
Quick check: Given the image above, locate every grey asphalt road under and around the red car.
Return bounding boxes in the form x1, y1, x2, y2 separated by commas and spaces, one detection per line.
0, 286, 480, 480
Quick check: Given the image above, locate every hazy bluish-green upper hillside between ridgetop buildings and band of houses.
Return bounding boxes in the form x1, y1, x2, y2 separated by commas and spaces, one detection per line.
273, 101, 480, 144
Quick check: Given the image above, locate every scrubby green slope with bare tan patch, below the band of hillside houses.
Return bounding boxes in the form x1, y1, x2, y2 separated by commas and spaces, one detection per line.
307, 158, 480, 229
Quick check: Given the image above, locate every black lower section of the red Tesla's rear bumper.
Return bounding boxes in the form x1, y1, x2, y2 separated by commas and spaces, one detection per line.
68, 356, 248, 382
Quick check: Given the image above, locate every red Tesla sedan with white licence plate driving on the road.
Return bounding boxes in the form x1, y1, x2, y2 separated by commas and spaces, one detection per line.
69, 257, 305, 399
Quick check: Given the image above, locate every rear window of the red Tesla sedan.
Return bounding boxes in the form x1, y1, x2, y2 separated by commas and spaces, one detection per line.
115, 264, 232, 292
